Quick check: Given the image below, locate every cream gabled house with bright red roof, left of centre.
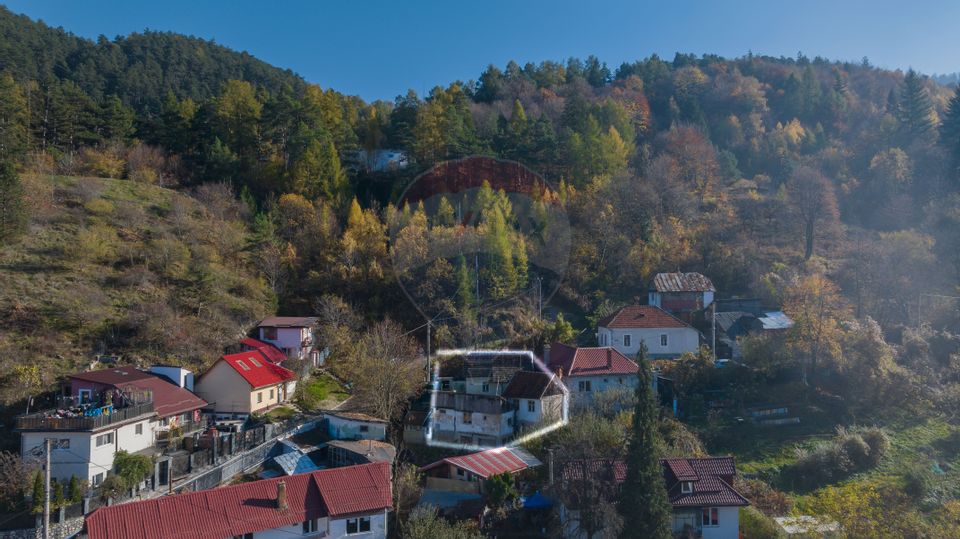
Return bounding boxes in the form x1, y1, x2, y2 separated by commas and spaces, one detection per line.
196, 350, 296, 419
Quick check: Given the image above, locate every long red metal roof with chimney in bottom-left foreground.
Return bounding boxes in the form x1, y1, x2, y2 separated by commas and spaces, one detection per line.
85, 462, 393, 539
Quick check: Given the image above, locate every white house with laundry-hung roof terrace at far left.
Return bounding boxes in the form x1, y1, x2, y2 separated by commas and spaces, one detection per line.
16, 366, 207, 486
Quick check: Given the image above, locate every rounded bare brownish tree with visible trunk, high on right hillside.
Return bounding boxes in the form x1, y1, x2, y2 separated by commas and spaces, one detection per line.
787, 166, 839, 260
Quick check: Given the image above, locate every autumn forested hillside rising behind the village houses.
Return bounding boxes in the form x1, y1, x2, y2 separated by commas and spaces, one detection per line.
0, 10, 960, 537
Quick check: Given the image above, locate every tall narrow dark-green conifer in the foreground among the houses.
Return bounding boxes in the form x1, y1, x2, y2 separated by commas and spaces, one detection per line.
619, 343, 672, 539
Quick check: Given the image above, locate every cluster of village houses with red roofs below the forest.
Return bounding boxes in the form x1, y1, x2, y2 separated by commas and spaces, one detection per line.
3, 273, 812, 539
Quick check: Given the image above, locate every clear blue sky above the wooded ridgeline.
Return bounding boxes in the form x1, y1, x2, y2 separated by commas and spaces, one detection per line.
6, 0, 960, 100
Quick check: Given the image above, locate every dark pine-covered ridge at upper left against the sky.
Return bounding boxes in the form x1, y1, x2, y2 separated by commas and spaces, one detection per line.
0, 6, 305, 112
